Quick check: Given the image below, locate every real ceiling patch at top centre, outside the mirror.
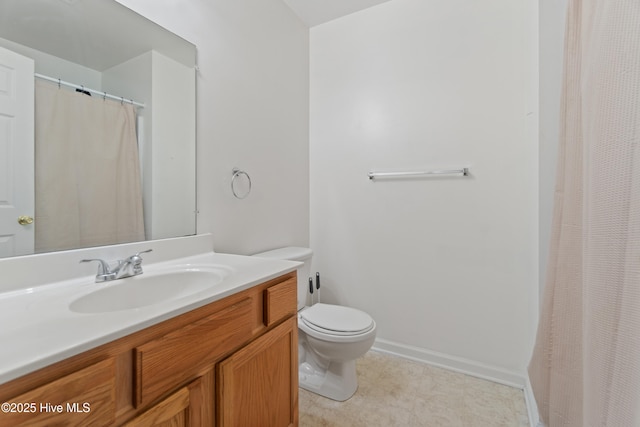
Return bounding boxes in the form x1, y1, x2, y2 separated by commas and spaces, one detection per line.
282, 0, 389, 27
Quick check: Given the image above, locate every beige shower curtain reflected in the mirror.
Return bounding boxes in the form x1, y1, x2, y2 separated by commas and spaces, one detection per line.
35, 81, 144, 252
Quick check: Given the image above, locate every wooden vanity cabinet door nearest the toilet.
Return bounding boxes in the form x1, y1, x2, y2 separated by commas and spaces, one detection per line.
216, 317, 298, 427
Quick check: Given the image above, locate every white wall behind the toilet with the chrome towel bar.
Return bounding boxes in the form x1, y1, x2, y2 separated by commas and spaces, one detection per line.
310, 0, 538, 378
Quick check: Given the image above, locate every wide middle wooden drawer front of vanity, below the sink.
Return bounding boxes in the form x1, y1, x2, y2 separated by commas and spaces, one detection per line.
135, 298, 252, 407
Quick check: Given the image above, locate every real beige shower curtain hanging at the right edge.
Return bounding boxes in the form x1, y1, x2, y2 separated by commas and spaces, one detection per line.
529, 0, 640, 427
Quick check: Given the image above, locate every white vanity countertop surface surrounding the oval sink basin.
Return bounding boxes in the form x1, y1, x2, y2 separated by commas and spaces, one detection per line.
0, 237, 300, 384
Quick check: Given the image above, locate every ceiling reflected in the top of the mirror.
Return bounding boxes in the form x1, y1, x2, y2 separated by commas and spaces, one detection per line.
0, 0, 196, 71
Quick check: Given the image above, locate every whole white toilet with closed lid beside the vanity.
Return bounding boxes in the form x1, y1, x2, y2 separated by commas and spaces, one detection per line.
254, 247, 376, 401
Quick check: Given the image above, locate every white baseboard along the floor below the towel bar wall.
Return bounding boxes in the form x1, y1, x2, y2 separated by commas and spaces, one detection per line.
372, 338, 544, 427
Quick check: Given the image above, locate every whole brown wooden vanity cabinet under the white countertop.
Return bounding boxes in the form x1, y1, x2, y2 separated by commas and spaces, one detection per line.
0, 272, 298, 427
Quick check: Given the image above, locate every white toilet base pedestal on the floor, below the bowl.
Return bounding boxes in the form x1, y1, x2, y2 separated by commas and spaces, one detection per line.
298, 360, 358, 402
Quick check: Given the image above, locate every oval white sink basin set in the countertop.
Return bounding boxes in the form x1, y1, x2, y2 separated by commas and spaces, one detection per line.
69, 266, 230, 313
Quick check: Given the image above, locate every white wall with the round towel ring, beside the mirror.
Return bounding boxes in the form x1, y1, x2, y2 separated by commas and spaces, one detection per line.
119, 0, 309, 254
